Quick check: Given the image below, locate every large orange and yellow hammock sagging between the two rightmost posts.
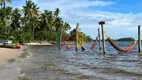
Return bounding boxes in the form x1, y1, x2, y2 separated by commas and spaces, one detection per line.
104, 32, 138, 52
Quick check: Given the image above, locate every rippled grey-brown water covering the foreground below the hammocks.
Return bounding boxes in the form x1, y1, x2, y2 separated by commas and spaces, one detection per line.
0, 42, 142, 80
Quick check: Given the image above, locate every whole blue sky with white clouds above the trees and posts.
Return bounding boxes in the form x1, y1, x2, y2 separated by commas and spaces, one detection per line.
9, 0, 142, 39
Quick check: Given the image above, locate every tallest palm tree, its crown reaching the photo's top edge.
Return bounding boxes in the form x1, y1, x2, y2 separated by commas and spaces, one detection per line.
23, 0, 39, 40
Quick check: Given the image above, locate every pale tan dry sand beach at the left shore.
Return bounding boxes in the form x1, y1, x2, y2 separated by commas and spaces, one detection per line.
0, 48, 21, 64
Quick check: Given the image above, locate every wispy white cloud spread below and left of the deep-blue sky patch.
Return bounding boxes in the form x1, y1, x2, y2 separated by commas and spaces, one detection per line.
11, 0, 142, 38
